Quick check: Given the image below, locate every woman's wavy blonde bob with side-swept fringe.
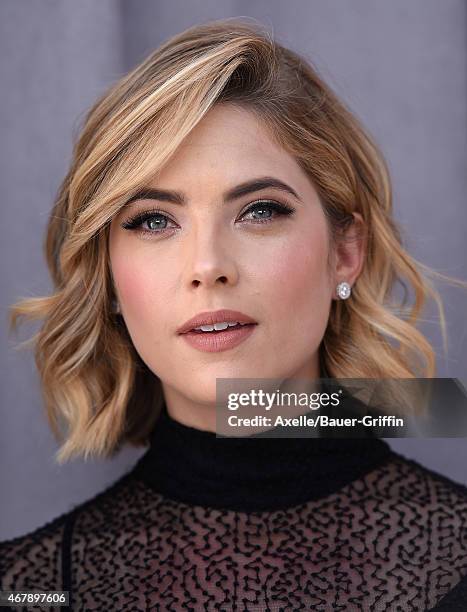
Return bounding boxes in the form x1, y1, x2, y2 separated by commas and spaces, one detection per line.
10, 19, 464, 463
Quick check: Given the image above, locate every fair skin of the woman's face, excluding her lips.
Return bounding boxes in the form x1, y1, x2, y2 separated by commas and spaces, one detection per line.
109, 104, 362, 422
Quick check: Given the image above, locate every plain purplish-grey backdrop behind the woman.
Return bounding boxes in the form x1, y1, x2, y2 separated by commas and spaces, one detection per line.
0, 0, 467, 539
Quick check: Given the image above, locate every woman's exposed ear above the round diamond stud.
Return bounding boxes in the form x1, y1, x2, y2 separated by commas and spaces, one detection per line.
333, 213, 366, 299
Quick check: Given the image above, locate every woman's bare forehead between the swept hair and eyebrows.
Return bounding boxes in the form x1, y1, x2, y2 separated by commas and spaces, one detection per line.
148, 103, 308, 194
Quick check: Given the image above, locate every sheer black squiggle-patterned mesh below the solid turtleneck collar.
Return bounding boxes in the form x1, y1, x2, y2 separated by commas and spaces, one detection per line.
0, 453, 467, 612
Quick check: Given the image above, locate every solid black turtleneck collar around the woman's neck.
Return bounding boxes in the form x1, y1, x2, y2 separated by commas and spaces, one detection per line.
135, 404, 392, 512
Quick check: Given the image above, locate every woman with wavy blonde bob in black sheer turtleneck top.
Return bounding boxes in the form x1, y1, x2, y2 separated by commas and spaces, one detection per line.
0, 20, 467, 611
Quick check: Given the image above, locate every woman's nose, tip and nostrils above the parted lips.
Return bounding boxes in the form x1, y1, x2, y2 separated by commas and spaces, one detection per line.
186, 226, 238, 289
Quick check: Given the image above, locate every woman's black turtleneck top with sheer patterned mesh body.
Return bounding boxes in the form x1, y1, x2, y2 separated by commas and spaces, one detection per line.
0, 402, 467, 612
